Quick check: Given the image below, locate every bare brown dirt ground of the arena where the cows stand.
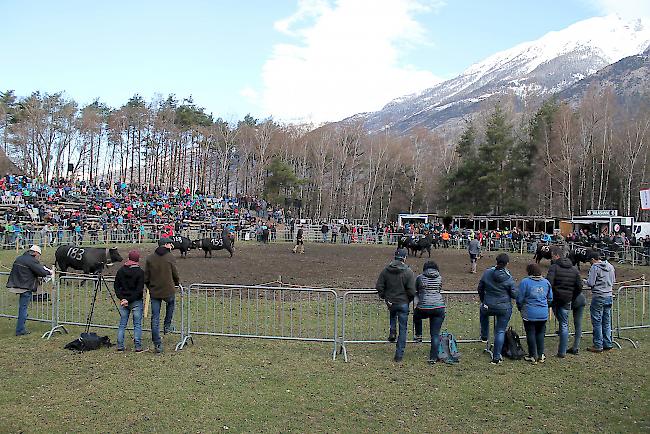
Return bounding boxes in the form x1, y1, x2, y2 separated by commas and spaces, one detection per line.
120, 242, 650, 291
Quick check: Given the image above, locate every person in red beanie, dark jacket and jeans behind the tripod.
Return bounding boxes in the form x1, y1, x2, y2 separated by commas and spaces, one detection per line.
114, 250, 144, 353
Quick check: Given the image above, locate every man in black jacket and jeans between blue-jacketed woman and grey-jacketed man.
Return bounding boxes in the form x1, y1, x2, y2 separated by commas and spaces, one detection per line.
546, 246, 587, 358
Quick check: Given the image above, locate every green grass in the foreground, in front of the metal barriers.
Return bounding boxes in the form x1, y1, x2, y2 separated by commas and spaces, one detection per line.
0, 319, 650, 433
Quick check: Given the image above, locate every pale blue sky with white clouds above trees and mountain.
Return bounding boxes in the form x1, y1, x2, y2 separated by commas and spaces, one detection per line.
0, 0, 650, 122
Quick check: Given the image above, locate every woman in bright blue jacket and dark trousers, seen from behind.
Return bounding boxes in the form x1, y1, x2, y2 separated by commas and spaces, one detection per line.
517, 264, 553, 365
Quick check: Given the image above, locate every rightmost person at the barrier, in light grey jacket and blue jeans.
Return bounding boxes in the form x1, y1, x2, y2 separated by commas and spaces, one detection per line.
586, 250, 616, 353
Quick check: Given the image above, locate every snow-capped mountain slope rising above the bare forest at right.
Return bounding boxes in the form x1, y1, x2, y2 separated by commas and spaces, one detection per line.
349, 15, 650, 133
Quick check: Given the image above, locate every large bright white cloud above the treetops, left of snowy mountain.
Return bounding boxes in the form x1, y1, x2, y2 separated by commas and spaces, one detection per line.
261, 0, 444, 122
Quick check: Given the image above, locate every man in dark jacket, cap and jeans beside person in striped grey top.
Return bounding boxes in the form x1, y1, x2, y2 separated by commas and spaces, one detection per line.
375, 249, 415, 363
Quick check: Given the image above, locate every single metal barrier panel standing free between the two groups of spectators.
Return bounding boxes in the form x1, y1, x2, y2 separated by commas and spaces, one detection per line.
182, 284, 338, 358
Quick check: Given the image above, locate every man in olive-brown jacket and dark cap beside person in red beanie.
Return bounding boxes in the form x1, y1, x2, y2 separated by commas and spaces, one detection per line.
144, 238, 180, 353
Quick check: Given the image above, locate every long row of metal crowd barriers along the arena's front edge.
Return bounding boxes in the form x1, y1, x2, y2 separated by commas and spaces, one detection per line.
0, 273, 650, 361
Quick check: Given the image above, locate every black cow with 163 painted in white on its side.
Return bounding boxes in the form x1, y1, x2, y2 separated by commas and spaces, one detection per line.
54, 245, 123, 274
